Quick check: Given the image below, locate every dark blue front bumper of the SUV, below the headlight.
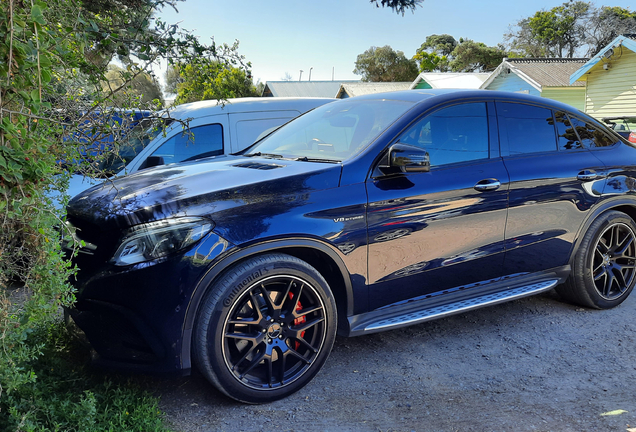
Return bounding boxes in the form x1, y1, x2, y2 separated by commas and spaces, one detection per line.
67, 233, 228, 373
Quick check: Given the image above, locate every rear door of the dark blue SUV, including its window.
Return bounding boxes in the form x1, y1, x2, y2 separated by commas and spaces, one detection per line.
496, 102, 606, 274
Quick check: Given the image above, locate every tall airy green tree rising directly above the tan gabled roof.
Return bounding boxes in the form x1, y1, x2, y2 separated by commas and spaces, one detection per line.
506, 0, 591, 58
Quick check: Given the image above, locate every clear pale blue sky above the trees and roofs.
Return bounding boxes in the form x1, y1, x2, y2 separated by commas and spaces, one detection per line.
158, 0, 634, 86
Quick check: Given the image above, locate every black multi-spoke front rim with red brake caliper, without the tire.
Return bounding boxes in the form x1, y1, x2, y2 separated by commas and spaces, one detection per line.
223, 275, 327, 390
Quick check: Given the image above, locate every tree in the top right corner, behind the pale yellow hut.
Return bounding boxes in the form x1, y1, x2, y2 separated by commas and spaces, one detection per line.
585, 6, 636, 57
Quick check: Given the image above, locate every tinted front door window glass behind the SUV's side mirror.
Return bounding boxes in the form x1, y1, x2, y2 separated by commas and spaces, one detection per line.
400, 102, 488, 166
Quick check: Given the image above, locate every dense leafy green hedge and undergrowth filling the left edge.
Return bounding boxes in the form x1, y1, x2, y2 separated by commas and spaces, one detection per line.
0, 0, 245, 431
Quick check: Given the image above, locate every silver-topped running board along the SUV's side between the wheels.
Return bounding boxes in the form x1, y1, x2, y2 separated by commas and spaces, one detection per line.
349, 278, 561, 336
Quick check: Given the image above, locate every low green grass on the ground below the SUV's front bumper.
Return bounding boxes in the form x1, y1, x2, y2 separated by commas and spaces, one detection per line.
0, 322, 166, 432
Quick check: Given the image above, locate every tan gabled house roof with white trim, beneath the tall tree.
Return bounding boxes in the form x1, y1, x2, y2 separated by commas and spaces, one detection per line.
481, 58, 587, 91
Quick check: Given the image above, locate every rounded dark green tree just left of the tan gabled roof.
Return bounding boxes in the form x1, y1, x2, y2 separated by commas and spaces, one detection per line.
450, 39, 506, 72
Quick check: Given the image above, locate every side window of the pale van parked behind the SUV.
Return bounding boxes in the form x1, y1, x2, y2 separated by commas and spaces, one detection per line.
152, 124, 223, 164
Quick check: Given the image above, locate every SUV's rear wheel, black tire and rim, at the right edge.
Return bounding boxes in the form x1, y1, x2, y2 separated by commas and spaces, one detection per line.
557, 211, 636, 309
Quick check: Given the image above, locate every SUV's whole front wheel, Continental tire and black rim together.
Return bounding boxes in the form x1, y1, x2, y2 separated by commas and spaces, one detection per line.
193, 253, 337, 404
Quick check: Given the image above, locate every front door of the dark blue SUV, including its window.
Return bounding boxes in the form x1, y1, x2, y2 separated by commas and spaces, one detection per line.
367, 101, 508, 310
